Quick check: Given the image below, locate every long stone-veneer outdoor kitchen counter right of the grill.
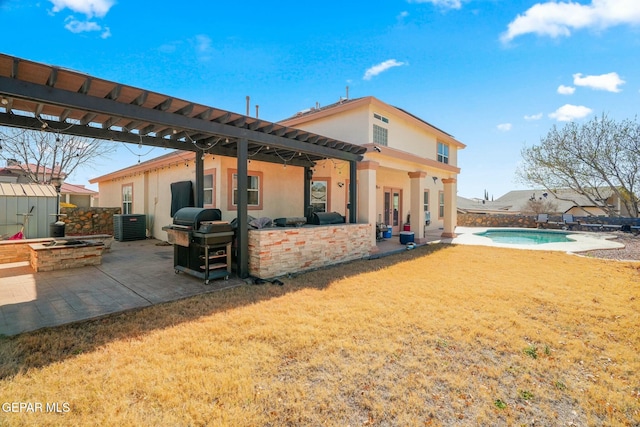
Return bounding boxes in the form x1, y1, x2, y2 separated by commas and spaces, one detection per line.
249, 224, 374, 279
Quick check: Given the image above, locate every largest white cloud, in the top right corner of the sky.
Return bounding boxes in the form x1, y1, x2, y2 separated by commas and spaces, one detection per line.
500, 0, 640, 43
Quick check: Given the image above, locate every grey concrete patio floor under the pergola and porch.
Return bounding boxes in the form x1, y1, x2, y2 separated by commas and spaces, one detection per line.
0, 233, 450, 336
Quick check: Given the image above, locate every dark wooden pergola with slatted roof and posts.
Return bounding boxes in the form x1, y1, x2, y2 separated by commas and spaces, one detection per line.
0, 54, 366, 278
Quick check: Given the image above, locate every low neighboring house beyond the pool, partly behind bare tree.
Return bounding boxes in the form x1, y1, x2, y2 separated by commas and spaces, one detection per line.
458, 189, 629, 216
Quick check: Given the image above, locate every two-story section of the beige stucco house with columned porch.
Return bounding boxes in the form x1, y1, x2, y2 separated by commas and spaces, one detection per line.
280, 96, 465, 241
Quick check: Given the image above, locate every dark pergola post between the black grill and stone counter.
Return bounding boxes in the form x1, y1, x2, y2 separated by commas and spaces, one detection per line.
232, 138, 249, 279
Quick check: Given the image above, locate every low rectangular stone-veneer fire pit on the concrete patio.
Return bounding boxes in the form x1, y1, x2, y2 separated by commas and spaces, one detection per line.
29, 242, 104, 271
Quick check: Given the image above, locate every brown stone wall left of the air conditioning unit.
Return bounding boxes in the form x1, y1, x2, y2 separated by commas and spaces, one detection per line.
60, 208, 121, 236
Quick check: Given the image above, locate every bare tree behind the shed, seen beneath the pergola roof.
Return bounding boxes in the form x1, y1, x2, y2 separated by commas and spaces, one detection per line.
0, 128, 116, 184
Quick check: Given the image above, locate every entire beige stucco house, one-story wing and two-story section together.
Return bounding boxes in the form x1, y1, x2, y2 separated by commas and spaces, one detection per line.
90, 97, 465, 246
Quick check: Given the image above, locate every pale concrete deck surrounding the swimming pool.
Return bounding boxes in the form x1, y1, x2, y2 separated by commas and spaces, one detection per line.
451, 227, 624, 253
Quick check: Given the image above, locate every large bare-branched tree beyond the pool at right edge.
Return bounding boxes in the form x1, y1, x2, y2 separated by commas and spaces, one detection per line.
517, 115, 640, 218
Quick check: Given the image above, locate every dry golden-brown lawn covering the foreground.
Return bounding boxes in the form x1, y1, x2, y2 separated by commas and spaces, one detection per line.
0, 246, 640, 426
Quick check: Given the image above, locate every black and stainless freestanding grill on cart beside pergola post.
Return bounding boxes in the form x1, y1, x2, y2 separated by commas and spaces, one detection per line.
162, 208, 233, 284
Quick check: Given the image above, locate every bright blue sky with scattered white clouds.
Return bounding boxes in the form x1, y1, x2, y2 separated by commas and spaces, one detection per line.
0, 0, 640, 198
